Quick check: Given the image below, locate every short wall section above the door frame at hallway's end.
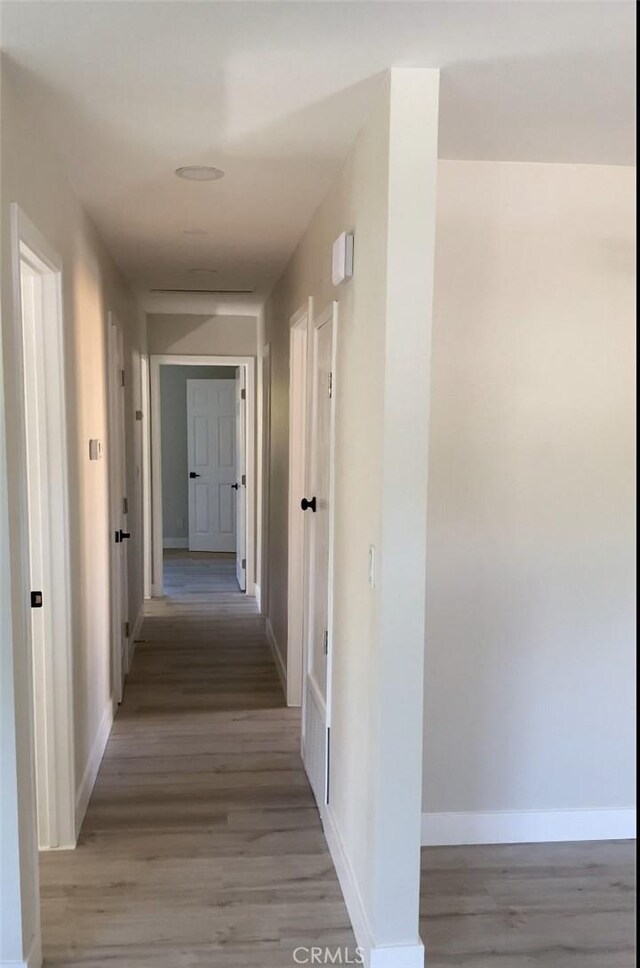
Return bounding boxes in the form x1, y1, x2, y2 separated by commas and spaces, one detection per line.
147, 313, 257, 356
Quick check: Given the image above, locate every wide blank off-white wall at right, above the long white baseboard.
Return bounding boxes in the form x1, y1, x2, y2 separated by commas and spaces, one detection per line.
424, 162, 635, 839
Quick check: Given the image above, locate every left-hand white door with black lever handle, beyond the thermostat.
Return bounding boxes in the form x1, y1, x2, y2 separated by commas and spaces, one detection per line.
108, 313, 130, 702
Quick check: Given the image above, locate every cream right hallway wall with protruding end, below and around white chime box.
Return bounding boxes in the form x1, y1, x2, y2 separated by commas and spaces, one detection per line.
261, 71, 438, 966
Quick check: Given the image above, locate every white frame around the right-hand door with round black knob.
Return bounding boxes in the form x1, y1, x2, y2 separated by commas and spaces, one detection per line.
300, 300, 339, 808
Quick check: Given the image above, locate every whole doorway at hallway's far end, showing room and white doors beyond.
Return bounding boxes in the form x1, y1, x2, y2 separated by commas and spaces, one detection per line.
150, 356, 255, 598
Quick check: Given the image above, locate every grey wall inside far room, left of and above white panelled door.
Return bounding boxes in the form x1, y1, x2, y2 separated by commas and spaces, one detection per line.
160, 366, 236, 548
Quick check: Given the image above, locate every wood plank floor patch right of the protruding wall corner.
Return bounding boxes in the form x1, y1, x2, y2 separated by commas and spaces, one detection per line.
420, 841, 636, 968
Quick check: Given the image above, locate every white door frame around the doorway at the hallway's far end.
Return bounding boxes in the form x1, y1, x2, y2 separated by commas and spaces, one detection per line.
149, 353, 256, 598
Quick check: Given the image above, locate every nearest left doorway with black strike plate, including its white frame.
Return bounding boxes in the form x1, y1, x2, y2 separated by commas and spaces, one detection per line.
11, 204, 77, 850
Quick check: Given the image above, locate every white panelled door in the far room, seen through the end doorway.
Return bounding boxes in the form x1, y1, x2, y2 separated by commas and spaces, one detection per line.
187, 380, 237, 552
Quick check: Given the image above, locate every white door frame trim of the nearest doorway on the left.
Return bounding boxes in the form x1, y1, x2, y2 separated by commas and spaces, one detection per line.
11, 202, 77, 849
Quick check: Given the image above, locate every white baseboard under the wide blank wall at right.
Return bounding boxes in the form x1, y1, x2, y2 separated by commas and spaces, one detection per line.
422, 810, 636, 847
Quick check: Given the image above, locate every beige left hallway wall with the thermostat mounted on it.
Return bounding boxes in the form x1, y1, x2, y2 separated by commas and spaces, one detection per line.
1, 60, 144, 952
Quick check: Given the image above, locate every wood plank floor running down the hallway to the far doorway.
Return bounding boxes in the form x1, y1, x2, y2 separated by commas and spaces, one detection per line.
40, 586, 355, 968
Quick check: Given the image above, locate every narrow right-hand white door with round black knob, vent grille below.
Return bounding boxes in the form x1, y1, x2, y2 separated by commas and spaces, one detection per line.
301, 309, 334, 811
